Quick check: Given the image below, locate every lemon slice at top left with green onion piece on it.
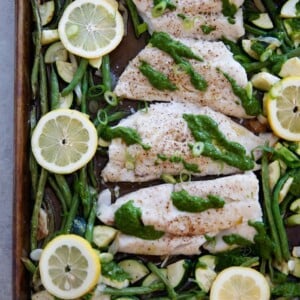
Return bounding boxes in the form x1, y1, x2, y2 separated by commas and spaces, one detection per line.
58, 0, 124, 58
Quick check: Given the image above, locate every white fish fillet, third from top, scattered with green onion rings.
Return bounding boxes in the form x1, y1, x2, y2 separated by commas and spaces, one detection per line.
102, 103, 273, 182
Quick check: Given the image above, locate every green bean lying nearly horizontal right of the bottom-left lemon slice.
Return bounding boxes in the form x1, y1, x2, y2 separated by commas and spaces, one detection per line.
103, 282, 165, 296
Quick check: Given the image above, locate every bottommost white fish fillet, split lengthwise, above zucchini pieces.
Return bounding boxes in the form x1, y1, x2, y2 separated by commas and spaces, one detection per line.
98, 172, 262, 255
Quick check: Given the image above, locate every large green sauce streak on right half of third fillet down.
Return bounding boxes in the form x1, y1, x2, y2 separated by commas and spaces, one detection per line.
183, 114, 255, 170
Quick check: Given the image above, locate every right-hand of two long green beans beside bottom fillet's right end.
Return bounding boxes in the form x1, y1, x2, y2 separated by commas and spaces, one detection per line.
272, 173, 290, 260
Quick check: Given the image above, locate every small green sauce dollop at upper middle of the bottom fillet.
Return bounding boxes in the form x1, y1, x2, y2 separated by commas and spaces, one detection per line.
171, 190, 225, 213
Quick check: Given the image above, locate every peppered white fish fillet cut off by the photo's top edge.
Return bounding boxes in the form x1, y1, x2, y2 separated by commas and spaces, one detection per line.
134, 0, 245, 41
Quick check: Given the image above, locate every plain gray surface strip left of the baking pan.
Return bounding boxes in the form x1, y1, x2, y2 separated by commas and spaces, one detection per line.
0, 0, 14, 300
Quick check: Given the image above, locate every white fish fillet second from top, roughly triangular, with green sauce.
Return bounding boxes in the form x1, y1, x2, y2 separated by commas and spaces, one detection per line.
114, 39, 250, 118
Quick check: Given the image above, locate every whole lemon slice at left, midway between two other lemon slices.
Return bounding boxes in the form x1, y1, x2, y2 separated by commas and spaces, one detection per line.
31, 108, 98, 174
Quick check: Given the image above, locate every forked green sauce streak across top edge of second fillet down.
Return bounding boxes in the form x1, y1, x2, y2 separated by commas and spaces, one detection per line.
150, 32, 207, 91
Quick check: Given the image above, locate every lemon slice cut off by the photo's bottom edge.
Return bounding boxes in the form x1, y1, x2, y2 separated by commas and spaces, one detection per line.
209, 267, 270, 300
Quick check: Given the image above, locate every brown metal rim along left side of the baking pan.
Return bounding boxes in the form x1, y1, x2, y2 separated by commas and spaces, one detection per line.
13, 0, 32, 300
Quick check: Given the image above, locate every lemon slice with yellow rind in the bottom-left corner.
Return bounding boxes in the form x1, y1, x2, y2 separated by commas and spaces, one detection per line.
39, 234, 101, 299
